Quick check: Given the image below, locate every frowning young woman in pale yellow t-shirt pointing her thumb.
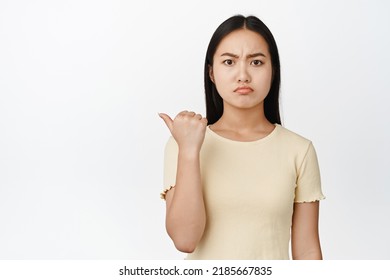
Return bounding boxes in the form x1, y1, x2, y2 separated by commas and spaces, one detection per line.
159, 15, 324, 259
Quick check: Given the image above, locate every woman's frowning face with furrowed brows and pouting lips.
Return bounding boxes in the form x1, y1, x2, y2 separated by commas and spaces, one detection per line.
209, 29, 272, 109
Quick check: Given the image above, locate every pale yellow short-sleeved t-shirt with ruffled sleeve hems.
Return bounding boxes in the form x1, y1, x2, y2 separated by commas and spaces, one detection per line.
164, 125, 325, 260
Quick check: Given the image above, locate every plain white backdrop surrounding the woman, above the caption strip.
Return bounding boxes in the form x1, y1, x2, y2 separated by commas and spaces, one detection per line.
0, 0, 390, 260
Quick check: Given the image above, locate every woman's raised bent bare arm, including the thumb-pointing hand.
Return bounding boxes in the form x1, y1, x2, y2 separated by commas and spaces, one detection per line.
159, 111, 207, 253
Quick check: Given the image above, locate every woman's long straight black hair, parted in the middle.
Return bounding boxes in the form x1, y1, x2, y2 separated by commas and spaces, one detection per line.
204, 15, 281, 124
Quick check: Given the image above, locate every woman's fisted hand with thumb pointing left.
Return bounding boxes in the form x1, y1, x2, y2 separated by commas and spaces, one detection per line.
159, 111, 207, 153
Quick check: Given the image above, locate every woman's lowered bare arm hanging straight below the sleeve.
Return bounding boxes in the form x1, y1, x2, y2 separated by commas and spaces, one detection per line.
291, 201, 322, 260
